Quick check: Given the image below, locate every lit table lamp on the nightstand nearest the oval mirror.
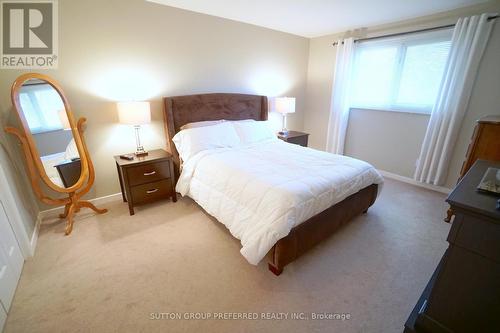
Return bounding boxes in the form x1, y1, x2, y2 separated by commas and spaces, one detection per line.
117, 102, 151, 156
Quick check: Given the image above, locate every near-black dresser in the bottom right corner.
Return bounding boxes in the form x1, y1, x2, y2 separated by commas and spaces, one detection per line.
404, 160, 500, 333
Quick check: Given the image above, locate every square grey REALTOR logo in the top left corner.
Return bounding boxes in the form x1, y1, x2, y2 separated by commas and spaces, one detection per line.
0, 0, 57, 69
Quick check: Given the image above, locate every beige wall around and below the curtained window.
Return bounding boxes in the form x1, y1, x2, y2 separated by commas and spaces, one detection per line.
304, 1, 500, 187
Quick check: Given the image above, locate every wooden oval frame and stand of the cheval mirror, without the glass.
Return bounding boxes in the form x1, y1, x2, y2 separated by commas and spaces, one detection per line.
5, 73, 107, 235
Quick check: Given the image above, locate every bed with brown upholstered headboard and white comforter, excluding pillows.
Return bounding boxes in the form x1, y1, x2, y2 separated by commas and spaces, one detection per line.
164, 94, 383, 275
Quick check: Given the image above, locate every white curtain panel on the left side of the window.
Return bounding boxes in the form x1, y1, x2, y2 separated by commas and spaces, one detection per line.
326, 38, 354, 154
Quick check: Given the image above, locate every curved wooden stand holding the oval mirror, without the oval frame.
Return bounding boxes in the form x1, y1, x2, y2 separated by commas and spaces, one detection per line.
5, 118, 108, 235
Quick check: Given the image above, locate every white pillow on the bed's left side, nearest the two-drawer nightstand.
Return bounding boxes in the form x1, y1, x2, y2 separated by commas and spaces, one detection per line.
172, 122, 240, 161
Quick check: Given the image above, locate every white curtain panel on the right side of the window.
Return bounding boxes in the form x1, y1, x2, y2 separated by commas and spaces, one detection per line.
414, 14, 494, 185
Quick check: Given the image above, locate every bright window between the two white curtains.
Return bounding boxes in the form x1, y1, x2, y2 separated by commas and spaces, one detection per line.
351, 29, 452, 113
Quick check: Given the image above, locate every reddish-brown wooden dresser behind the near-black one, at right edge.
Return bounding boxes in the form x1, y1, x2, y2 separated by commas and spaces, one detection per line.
444, 116, 500, 222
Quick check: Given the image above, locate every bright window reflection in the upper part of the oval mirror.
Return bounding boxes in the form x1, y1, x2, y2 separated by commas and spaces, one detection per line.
19, 84, 64, 133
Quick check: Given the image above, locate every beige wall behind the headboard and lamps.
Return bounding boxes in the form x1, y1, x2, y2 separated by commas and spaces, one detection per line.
0, 0, 309, 215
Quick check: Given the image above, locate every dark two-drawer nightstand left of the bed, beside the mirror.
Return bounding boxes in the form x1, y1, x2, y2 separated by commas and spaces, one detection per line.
115, 149, 177, 215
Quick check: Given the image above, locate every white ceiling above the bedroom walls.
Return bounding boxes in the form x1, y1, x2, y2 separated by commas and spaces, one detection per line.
148, 0, 488, 37
